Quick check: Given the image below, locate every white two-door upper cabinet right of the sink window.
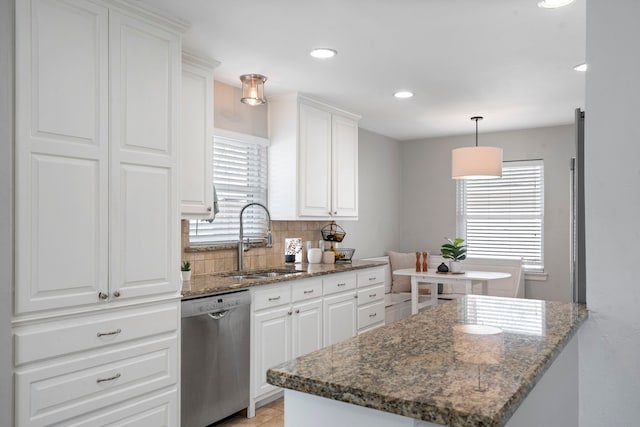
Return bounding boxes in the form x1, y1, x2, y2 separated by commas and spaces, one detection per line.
268, 94, 360, 220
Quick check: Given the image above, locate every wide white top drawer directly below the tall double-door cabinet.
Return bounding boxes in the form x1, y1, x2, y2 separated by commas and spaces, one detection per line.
14, 301, 180, 366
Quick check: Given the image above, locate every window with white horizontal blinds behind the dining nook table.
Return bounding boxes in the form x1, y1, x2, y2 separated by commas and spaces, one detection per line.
457, 160, 544, 271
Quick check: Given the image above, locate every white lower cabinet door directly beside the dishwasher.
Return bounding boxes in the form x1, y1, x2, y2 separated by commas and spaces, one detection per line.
252, 306, 292, 397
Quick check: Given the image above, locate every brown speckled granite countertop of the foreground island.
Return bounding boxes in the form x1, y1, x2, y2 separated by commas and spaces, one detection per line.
267, 295, 588, 426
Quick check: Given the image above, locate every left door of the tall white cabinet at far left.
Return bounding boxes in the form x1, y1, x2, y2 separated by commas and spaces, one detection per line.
15, 0, 109, 314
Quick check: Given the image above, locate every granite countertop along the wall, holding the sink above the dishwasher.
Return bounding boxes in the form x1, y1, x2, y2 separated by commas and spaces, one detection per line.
182, 260, 385, 299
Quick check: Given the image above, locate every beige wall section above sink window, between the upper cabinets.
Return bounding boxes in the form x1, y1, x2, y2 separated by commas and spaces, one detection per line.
213, 80, 269, 138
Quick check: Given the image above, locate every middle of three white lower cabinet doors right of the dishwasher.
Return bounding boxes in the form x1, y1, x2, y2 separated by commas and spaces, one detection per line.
291, 299, 323, 358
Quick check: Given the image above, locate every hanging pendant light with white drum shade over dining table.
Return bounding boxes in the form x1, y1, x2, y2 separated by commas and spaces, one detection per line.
451, 116, 502, 179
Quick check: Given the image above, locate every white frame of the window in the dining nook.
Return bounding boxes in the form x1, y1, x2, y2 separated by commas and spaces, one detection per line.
456, 159, 545, 273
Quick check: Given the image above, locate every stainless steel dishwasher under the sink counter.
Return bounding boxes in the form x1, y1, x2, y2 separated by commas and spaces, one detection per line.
180, 290, 251, 427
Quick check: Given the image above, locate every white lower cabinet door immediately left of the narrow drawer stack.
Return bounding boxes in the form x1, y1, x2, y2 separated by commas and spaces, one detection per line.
323, 291, 356, 347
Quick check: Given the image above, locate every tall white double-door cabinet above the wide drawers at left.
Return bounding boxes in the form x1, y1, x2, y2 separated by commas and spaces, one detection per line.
15, 0, 184, 314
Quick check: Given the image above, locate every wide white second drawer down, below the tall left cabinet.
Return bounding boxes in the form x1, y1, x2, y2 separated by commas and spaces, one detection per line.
15, 334, 178, 426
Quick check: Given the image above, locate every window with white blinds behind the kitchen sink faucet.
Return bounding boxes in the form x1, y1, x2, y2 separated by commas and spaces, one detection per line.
189, 131, 267, 245
